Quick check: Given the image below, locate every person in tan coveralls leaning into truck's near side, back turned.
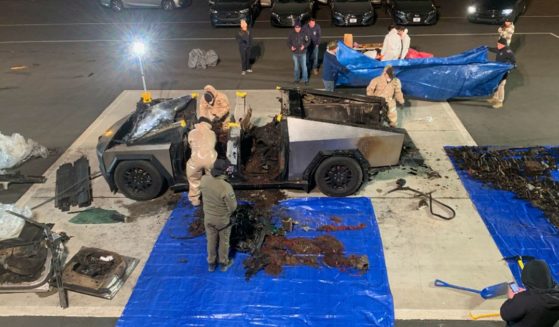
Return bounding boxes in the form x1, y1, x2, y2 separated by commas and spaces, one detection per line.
186, 117, 217, 206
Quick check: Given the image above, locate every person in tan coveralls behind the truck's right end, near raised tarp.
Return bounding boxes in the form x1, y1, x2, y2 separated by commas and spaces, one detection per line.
367, 65, 404, 127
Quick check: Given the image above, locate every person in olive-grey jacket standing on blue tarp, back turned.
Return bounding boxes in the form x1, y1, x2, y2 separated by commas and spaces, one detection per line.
200, 159, 237, 272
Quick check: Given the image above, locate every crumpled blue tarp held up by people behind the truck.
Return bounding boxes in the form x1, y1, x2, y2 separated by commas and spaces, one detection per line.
336, 42, 513, 101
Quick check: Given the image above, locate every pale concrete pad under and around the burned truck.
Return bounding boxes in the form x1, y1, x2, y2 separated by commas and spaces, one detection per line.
0, 90, 512, 326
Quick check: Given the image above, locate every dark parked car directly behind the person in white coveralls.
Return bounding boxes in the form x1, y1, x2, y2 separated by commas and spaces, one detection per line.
386, 0, 439, 25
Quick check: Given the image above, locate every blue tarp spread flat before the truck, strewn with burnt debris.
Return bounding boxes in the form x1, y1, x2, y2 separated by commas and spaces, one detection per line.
117, 196, 394, 327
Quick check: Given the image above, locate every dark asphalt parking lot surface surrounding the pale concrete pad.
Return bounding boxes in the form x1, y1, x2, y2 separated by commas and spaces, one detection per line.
0, 0, 559, 326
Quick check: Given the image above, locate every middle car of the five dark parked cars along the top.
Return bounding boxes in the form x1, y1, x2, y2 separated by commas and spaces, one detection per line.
330, 0, 377, 26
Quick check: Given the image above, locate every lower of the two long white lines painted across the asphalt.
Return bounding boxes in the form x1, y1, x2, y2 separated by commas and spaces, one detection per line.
0, 32, 559, 45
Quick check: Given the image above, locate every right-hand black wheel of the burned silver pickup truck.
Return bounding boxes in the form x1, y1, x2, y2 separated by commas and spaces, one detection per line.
314, 157, 363, 196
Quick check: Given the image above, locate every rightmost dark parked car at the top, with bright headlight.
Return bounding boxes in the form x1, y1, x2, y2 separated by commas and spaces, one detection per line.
468, 0, 527, 24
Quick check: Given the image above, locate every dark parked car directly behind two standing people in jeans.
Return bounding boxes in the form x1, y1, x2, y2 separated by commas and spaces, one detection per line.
271, 0, 315, 27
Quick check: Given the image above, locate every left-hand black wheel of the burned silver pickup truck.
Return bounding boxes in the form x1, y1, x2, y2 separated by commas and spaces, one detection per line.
115, 160, 165, 201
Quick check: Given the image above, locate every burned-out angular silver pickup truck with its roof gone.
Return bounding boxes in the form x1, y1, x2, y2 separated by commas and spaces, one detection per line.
97, 88, 405, 201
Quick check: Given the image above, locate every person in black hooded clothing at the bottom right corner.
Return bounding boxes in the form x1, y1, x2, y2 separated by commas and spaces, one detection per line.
501, 260, 559, 327
